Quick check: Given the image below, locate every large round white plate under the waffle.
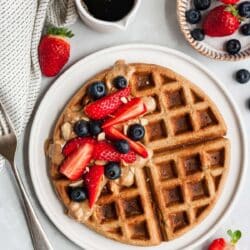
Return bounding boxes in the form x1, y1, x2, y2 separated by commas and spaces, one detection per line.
29, 44, 246, 250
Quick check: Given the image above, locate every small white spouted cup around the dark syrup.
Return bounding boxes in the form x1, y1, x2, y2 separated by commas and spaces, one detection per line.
75, 0, 141, 32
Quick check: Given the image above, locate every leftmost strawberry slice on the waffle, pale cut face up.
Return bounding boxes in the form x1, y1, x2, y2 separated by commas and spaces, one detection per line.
60, 142, 94, 181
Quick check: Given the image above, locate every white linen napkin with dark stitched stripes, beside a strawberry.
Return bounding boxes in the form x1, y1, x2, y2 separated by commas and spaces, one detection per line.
0, 0, 77, 169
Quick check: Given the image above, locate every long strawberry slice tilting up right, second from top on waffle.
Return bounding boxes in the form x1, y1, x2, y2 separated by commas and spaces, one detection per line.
102, 98, 147, 128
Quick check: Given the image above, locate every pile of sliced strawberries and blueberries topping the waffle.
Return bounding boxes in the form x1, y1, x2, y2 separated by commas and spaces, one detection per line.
60, 75, 152, 208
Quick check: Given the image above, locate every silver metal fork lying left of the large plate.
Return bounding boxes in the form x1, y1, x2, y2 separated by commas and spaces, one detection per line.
0, 102, 53, 250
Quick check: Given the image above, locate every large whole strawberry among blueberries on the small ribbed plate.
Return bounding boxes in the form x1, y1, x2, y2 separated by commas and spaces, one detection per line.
203, 5, 240, 37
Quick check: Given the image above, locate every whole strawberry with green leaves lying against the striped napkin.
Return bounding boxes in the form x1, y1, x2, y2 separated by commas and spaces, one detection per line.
38, 27, 74, 76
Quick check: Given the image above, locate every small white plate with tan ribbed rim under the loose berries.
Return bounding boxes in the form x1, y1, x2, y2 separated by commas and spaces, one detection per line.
177, 0, 250, 61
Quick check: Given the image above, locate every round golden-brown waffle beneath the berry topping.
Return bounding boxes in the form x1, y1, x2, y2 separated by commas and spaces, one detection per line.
47, 62, 230, 246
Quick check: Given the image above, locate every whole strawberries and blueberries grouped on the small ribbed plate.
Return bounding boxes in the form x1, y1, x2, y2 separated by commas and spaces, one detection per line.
185, 0, 250, 55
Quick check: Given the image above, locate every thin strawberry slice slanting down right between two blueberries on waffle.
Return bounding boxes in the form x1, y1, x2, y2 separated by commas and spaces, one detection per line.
104, 127, 148, 158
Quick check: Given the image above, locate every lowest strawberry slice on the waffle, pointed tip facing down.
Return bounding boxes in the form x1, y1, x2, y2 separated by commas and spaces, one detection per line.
83, 165, 104, 208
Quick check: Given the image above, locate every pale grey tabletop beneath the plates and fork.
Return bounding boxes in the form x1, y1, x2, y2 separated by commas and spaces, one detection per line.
0, 0, 250, 250
